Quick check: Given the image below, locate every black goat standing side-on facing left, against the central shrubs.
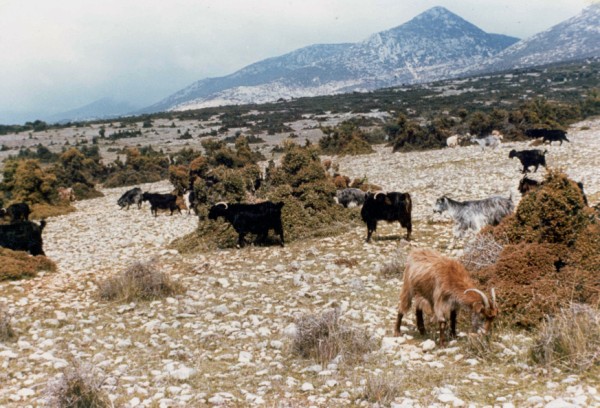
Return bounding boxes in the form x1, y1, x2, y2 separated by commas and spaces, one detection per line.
208, 201, 284, 247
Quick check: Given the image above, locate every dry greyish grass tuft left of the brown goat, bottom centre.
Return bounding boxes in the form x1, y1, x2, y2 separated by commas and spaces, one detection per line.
292, 309, 375, 364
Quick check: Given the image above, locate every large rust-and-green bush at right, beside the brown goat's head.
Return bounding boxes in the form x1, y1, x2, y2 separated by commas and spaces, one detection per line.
474, 170, 600, 328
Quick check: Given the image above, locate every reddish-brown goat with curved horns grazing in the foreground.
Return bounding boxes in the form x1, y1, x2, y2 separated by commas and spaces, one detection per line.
394, 249, 498, 346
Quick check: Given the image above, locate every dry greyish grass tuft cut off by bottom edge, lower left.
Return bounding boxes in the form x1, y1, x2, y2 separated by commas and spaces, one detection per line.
46, 363, 112, 408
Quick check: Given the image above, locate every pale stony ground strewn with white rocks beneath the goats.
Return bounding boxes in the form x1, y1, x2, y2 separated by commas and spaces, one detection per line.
0, 120, 600, 408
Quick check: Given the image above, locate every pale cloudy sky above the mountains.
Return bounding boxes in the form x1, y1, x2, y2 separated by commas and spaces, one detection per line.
0, 0, 598, 124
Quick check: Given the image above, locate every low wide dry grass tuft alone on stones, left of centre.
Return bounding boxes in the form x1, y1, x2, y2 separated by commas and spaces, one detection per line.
98, 262, 183, 302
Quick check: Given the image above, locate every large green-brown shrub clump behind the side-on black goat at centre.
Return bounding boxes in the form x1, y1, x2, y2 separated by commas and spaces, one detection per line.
173, 143, 358, 252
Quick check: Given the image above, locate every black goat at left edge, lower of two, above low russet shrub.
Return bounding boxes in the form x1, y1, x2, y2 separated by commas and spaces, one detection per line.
0, 220, 46, 255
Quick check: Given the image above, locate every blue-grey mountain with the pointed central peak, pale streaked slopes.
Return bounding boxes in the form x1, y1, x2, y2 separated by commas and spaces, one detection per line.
140, 7, 518, 113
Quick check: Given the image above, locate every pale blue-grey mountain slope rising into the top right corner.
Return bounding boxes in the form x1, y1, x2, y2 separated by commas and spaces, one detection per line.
472, 4, 600, 73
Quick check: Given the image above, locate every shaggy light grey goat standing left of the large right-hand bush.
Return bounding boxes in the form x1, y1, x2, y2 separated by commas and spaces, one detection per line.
433, 196, 515, 238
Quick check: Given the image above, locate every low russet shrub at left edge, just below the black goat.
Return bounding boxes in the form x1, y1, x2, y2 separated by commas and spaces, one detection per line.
0, 248, 56, 281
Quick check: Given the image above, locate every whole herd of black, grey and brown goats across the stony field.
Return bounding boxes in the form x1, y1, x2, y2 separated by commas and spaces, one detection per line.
0, 129, 587, 345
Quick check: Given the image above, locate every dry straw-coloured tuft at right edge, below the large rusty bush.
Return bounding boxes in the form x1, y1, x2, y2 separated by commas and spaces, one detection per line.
531, 304, 600, 372
